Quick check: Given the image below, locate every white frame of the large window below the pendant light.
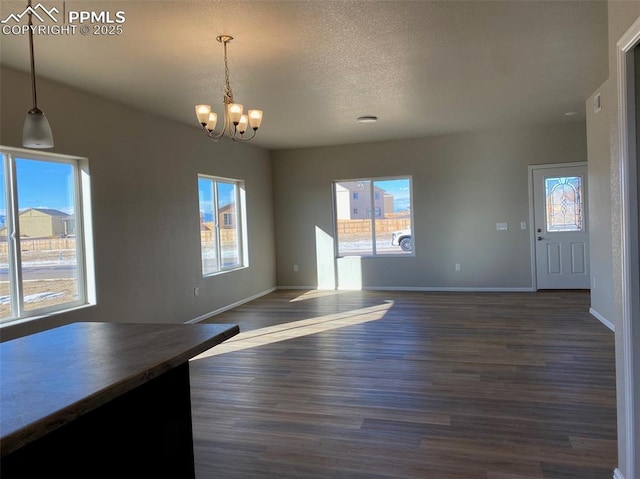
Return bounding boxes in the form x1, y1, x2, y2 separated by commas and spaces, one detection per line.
0, 145, 96, 327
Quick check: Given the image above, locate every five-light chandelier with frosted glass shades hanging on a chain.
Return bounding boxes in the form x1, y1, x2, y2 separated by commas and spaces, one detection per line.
196, 35, 262, 141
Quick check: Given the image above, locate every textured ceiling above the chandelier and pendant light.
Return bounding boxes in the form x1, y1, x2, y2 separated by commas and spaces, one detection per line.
0, 0, 608, 148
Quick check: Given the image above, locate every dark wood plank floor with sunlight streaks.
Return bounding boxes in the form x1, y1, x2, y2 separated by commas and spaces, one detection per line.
191, 291, 617, 479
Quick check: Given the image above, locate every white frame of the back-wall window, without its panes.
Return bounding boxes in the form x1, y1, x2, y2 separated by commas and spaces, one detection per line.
331, 175, 416, 259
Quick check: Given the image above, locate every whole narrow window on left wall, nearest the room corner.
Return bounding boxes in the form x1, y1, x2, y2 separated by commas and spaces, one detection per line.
198, 175, 247, 276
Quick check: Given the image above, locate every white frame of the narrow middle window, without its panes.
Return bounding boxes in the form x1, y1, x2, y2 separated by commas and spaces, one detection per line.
197, 173, 249, 278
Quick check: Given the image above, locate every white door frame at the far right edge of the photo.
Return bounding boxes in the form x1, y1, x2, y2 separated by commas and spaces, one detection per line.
614, 14, 640, 479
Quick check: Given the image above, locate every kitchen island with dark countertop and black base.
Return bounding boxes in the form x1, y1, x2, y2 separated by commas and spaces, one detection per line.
0, 322, 239, 479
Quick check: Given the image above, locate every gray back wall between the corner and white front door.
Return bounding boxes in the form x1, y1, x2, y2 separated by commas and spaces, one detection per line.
273, 122, 587, 289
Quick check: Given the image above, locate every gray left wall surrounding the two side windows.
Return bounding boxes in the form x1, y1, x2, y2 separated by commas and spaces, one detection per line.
0, 69, 275, 340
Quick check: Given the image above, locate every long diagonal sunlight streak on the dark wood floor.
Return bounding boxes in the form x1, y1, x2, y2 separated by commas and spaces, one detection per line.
191, 301, 394, 361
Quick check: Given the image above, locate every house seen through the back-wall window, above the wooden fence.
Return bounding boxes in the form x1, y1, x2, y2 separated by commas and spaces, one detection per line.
336, 181, 393, 220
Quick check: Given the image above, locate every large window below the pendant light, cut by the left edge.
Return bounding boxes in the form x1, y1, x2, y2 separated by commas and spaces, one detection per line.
0, 147, 95, 322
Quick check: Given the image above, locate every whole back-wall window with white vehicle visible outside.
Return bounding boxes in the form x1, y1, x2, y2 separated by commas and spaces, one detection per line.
333, 177, 412, 256
